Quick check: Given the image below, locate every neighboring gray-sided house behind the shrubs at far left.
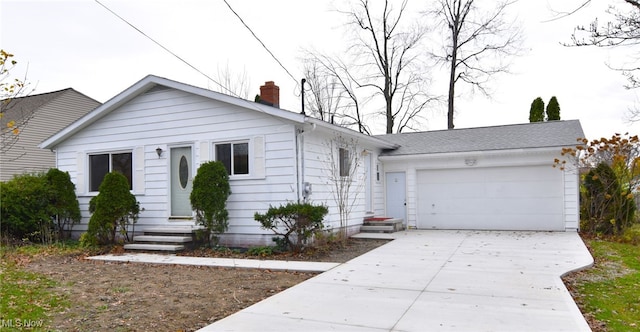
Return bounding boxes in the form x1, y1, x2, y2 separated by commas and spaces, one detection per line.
0, 88, 100, 181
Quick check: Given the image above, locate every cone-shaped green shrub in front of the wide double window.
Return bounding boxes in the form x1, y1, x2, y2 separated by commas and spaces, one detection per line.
82, 172, 140, 244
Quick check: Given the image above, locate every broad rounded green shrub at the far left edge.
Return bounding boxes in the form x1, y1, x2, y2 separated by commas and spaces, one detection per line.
0, 174, 53, 243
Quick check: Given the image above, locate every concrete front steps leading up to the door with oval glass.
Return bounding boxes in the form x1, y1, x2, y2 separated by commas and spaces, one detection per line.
124, 226, 204, 252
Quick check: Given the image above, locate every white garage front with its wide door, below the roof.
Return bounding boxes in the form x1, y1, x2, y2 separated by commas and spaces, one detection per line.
382, 149, 579, 230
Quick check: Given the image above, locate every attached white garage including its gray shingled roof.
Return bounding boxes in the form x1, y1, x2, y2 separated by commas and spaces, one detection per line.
380, 120, 584, 231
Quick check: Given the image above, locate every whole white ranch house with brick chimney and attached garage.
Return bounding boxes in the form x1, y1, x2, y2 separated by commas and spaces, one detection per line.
40, 76, 584, 246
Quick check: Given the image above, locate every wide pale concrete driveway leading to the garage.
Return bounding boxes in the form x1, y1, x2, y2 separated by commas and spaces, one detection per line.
201, 230, 593, 331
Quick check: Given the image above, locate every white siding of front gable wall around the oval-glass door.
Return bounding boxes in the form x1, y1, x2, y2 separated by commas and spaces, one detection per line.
52, 89, 297, 239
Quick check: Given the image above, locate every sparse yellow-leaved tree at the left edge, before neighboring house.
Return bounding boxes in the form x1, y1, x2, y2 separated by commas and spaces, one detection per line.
0, 50, 34, 161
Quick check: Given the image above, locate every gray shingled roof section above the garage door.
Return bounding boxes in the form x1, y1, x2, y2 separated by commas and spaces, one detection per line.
376, 120, 585, 156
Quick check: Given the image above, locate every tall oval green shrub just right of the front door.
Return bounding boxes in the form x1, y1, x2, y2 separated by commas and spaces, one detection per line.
189, 161, 231, 246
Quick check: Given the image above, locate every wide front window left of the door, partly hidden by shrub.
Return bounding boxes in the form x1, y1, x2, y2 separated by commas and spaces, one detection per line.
89, 152, 133, 191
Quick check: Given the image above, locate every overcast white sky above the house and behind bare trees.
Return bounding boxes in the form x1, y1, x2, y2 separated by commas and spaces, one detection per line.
0, 0, 640, 139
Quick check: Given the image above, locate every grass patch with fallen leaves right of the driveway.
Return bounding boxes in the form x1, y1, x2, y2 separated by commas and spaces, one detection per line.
572, 239, 640, 331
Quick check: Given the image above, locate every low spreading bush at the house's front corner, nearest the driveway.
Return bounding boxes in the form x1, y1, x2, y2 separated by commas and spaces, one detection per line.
254, 202, 329, 252
